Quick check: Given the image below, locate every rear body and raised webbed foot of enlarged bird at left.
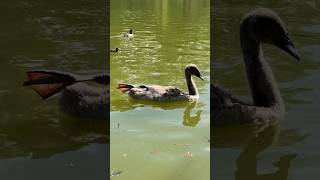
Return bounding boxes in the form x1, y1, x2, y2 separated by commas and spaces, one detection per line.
23, 70, 110, 119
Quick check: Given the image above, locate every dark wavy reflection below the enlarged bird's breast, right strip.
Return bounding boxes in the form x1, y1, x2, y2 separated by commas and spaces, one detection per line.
211, 124, 307, 180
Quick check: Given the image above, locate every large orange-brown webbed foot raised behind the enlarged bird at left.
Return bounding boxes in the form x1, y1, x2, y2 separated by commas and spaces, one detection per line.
23, 71, 78, 99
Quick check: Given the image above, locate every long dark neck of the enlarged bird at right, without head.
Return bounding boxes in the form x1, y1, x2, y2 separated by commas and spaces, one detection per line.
241, 32, 285, 112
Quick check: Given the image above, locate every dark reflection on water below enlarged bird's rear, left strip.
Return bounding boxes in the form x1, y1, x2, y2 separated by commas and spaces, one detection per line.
0, 117, 109, 159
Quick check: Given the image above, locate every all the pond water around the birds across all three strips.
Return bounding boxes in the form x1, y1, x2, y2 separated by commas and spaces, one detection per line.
0, 0, 320, 180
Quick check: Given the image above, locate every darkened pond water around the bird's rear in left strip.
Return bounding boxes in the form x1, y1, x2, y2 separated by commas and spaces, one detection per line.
0, 0, 109, 180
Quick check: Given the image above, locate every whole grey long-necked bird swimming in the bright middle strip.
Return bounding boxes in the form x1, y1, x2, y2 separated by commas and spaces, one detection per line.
118, 64, 203, 101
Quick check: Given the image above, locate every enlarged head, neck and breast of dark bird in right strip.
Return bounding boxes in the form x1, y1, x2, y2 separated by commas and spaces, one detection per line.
211, 8, 300, 124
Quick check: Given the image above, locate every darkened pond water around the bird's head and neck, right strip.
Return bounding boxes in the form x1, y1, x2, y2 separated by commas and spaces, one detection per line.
211, 0, 320, 180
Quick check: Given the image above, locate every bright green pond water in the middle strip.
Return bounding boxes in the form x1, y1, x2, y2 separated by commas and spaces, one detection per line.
110, 0, 210, 180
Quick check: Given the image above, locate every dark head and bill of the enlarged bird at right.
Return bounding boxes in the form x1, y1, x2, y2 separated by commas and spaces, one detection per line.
240, 8, 300, 60
